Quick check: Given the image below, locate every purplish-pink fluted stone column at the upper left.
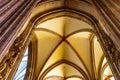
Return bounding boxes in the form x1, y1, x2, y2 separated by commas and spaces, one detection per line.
0, 0, 39, 62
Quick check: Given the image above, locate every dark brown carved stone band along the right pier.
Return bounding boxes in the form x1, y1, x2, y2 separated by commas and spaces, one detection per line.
97, 23, 120, 80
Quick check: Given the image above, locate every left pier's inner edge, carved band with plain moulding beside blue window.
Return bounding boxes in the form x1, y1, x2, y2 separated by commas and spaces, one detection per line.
0, 16, 32, 80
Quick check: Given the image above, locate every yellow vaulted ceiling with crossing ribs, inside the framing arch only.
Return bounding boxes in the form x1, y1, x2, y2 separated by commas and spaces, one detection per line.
31, 16, 111, 80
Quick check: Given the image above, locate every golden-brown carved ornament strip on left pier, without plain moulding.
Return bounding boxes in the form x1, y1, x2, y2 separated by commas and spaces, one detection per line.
0, 25, 28, 80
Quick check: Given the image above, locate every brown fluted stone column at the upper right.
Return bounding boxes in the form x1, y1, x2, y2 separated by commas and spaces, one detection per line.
93, 0, 120, 52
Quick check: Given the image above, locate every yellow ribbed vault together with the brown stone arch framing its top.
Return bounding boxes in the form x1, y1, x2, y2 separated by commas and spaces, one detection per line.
15, 0, 112, 80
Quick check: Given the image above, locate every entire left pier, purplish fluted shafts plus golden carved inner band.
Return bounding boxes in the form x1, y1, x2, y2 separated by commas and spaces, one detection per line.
0, 0, 40, 80
